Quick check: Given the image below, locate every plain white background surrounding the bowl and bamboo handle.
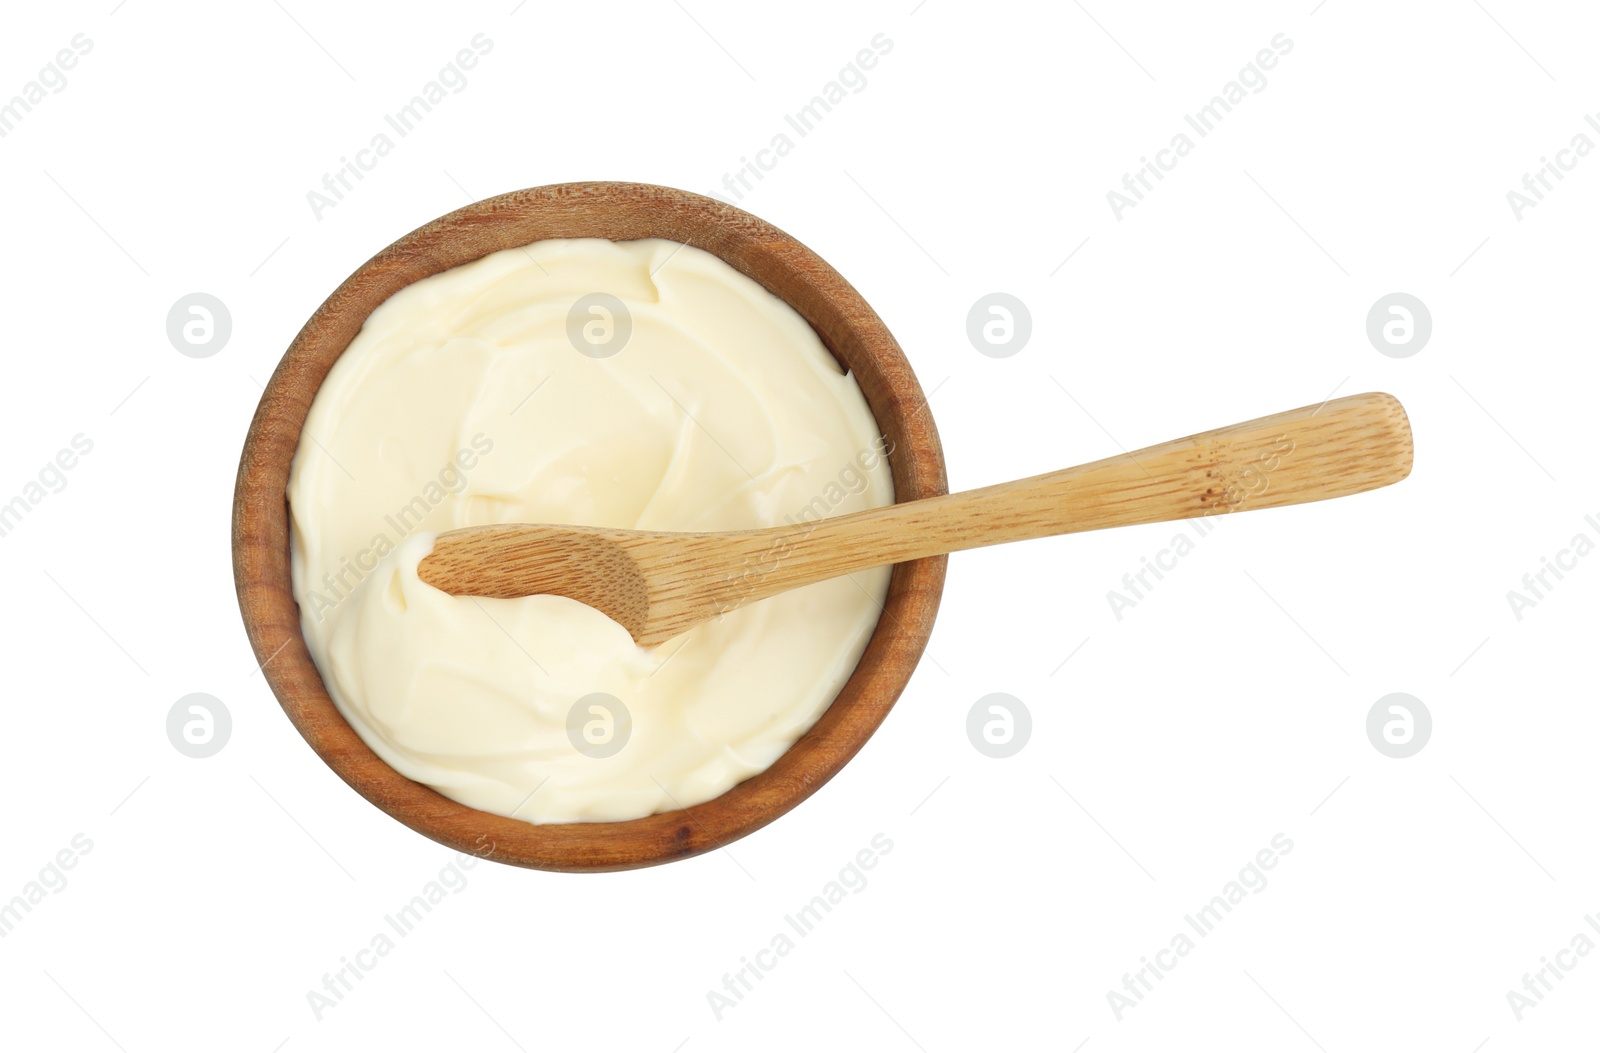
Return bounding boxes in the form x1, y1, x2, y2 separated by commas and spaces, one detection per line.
0, 0, 1600, 1053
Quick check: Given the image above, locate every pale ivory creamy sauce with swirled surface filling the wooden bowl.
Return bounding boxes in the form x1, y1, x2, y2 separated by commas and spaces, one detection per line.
288, 240, 893, 823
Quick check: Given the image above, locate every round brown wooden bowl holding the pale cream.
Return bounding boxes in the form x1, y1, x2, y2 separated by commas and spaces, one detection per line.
234, 182, 946, 871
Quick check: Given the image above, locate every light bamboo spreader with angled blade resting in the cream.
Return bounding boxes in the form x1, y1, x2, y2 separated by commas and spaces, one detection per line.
418, 392, 1411, 647
